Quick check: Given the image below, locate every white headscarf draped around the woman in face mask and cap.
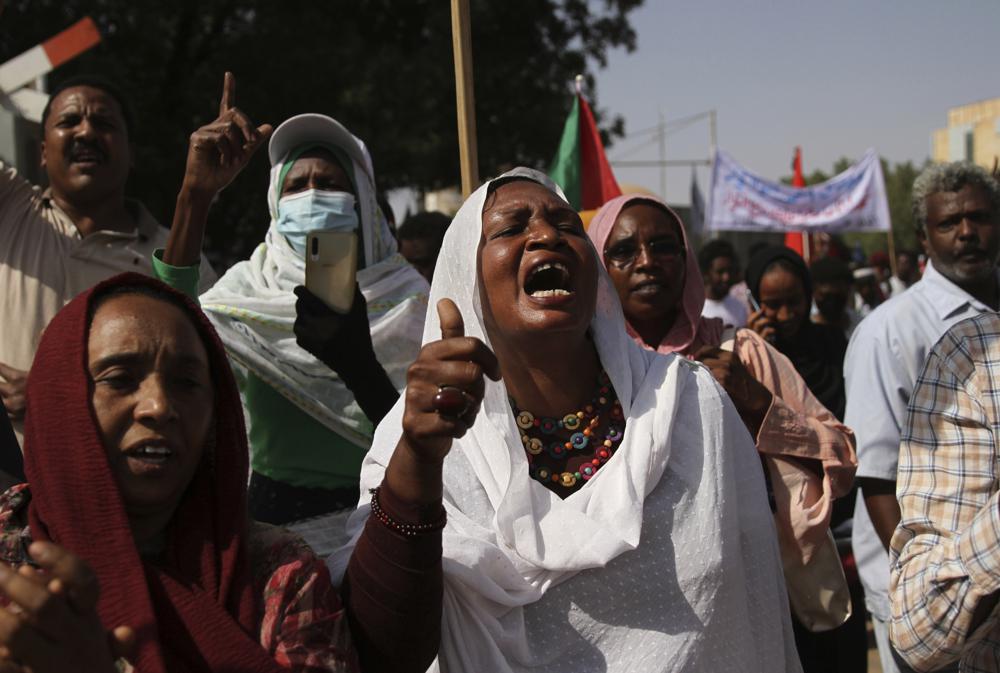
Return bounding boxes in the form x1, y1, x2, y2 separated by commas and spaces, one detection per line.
201, 122, 428, 447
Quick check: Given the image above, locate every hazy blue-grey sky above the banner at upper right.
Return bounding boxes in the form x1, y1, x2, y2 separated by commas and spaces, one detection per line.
596, 0, 1000, 203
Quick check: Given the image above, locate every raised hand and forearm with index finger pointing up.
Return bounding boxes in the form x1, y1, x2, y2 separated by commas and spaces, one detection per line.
163, 72, 274, 266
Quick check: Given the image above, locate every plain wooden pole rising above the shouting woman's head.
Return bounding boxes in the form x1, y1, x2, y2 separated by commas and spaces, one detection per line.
451, 0, 479, 197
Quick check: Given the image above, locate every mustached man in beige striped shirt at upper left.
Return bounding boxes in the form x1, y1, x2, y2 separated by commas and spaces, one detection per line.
0, 77, 215, 439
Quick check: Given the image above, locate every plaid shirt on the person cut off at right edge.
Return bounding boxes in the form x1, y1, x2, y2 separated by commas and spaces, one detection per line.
889, 313, 1000, 673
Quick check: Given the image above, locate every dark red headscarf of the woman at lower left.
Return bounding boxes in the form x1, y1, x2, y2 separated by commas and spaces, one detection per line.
24, 274, 284, 673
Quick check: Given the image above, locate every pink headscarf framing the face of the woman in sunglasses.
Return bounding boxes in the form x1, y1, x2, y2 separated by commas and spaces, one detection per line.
587, 194, 723, 357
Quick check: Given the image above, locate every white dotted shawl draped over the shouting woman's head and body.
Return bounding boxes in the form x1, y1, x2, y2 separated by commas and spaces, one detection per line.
329, 168, 798, 673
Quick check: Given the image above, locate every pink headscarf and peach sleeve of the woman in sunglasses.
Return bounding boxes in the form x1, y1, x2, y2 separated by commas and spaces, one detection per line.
587, 194, 858, 563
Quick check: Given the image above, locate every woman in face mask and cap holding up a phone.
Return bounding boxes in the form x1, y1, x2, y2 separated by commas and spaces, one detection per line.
154, 73, 428, 554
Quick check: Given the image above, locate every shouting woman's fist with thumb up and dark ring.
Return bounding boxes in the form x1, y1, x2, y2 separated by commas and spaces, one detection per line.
385, 299, 500, 505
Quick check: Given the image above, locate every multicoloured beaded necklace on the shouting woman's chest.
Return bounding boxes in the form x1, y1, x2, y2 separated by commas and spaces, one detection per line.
510, 370, 625, 489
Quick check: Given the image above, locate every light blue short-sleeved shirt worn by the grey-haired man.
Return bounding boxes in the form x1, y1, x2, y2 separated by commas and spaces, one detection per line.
844, 262, 992, 621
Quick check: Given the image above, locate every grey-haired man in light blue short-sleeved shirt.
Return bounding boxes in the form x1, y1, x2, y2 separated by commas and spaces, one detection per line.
844, 162, 1000, 673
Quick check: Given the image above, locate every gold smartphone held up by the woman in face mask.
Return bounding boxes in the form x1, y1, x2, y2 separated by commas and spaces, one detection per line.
306, 230, 358, 313
